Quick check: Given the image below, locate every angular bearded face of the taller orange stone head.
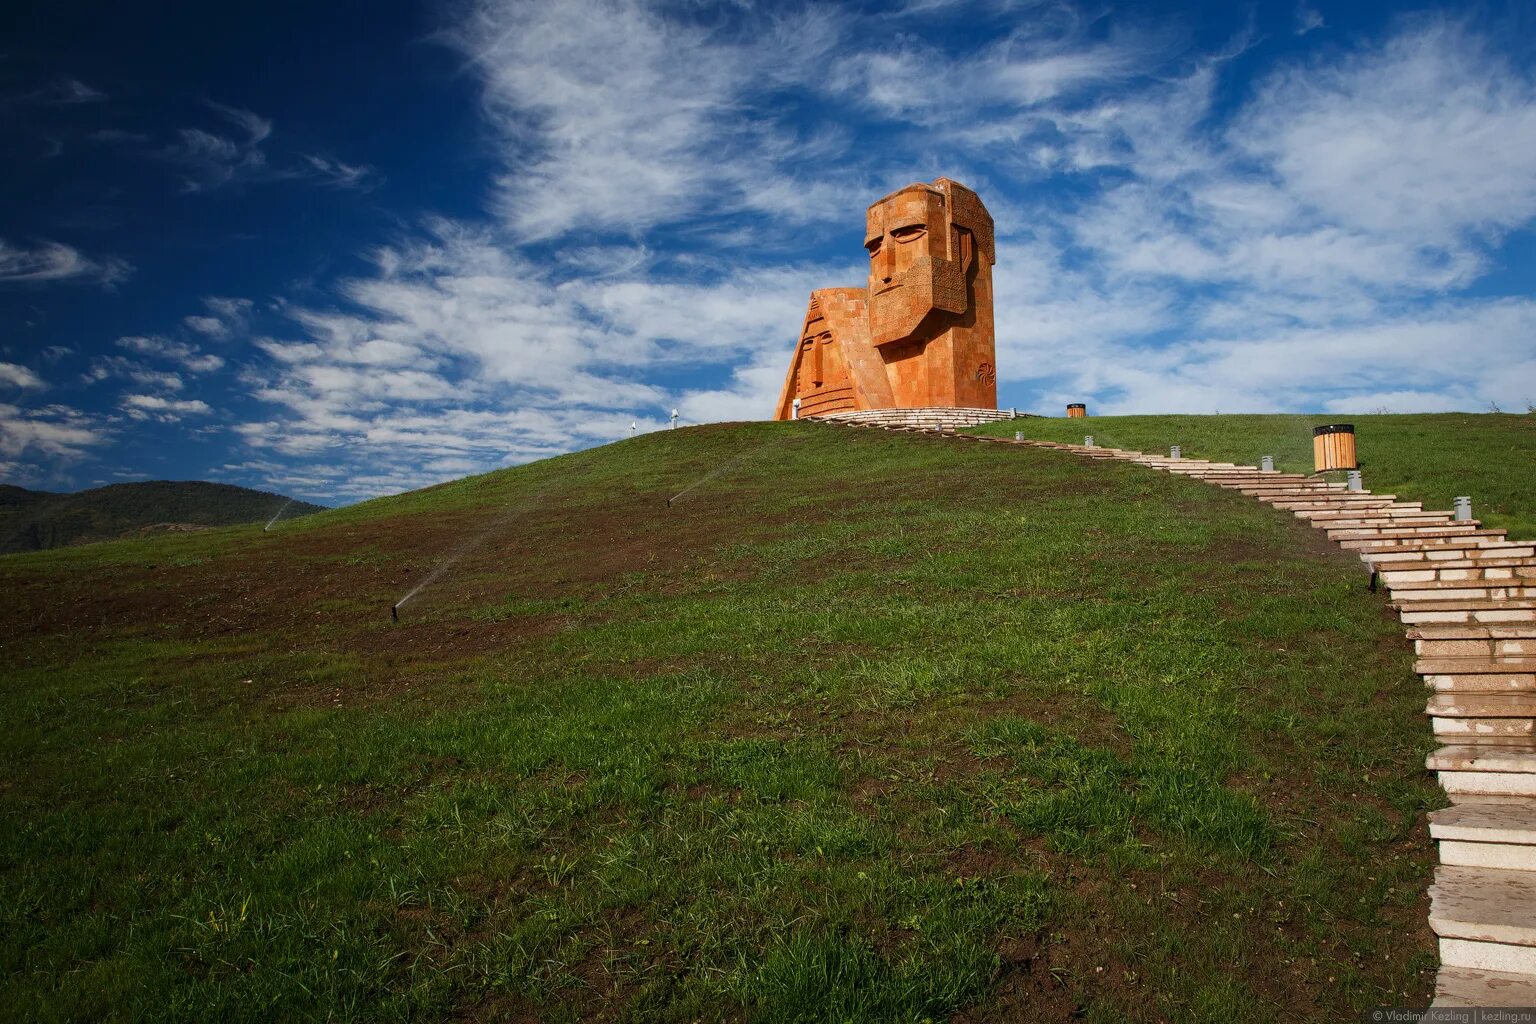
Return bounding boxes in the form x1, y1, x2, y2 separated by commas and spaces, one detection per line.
865, 189, 966, 345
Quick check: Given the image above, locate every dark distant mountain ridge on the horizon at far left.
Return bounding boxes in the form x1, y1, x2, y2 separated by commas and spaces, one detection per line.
0, 481, 324, 553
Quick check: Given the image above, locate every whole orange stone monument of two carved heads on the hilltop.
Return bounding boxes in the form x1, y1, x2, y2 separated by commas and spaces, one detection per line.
774, 178, 997, 419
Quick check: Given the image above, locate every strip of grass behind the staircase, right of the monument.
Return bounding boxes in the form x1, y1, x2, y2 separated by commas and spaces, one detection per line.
975, 413, 1536, 537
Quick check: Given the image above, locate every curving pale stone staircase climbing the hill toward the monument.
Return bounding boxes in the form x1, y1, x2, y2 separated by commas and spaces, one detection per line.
823, 421, 1536, 1007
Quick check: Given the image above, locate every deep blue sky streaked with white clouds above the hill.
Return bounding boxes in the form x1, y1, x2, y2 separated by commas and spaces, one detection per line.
0, 0, 1536, 502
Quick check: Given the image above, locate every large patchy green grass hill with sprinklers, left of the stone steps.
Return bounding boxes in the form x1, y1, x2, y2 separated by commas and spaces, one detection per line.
0, 421, 1462, 1022
